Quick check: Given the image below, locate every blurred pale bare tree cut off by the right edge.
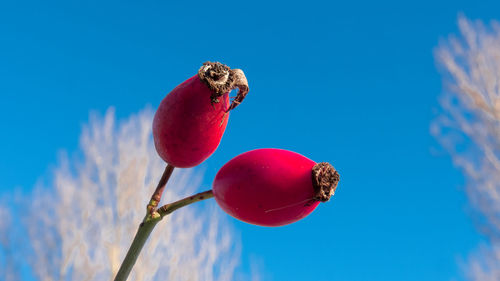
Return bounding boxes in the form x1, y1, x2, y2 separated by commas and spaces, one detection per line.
431, 16, 500, 281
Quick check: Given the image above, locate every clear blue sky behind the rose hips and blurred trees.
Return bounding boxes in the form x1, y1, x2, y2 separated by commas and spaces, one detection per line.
0, 0, 500, 281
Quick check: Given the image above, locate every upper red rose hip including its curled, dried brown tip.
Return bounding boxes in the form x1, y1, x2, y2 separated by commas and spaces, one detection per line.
153, 62, 248, 168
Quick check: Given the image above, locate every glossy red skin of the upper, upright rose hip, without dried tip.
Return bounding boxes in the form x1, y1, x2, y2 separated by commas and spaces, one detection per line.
153, 75, 229, 168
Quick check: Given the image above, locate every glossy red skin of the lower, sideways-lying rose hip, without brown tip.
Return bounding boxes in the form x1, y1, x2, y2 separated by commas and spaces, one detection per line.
212, 148, 319, 226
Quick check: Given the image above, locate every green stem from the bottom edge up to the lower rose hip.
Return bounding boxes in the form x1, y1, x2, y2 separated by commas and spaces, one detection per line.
115, 190, 214, 281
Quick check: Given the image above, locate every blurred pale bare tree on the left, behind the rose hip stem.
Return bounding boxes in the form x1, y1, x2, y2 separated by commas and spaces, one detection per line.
0, 106, 239, 281
